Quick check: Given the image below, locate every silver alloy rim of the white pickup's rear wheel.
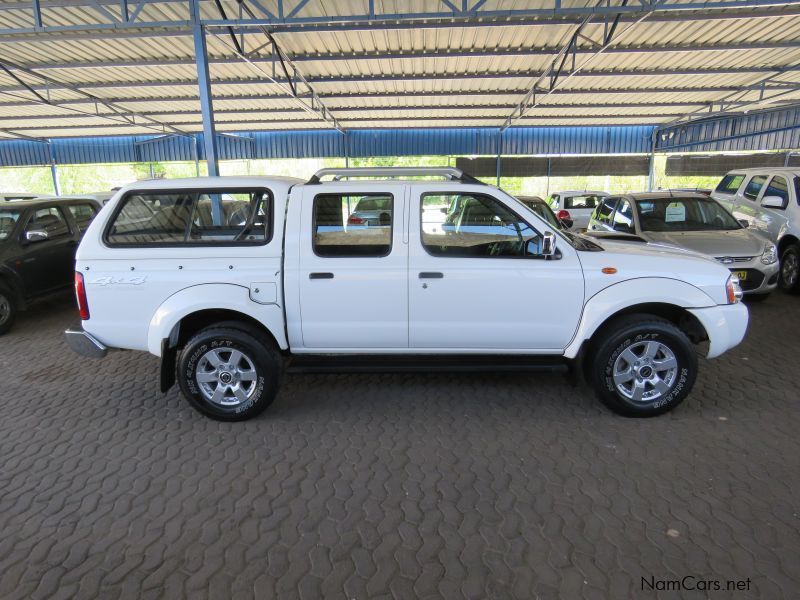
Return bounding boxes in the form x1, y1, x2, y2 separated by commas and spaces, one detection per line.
194, 348, 258, 408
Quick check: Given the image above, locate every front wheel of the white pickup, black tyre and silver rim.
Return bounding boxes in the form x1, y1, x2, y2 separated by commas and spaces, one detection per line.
589, 315, 697, 417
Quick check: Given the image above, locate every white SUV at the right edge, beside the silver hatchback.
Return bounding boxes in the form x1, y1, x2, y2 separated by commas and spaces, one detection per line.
711, 167, 800, 293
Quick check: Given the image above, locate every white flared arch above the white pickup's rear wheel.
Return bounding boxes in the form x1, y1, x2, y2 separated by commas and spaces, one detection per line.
147, 283, 289, 356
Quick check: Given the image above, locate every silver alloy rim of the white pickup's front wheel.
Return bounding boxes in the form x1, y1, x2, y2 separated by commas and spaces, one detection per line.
613, 341, 678, 402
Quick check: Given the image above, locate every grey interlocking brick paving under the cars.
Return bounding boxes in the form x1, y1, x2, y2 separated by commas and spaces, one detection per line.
0, 294, 800, 600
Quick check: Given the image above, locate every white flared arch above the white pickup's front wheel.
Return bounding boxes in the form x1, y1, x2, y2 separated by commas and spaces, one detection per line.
564, 277, 716, 358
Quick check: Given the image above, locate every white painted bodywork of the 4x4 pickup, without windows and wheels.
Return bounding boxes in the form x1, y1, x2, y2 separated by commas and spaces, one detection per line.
68, 170, 748, 418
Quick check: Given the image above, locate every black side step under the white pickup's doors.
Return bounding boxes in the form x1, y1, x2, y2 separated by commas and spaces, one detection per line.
287, 354, 569, 373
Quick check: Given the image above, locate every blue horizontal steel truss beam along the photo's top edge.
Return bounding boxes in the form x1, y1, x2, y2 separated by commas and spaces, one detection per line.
0, 0, 798, 35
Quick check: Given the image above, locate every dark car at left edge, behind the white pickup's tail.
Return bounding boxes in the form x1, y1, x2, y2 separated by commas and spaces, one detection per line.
0, 198, 100, 335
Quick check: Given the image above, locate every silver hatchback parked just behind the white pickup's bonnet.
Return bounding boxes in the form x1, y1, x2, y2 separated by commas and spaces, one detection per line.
589, 192, 778, 300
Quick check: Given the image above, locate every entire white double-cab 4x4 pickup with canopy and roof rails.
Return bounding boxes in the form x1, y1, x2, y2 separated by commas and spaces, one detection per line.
66, 168, 748, 421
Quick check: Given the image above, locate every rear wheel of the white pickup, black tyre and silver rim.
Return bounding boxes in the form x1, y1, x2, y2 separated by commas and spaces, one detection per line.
178, 327, 282, 421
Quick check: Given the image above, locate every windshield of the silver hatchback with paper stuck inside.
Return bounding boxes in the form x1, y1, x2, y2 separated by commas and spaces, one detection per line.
636, 198, 742, 231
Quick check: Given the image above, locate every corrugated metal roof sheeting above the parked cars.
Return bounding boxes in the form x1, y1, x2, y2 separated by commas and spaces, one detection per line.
0, 0, 800, 138
